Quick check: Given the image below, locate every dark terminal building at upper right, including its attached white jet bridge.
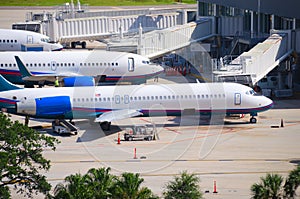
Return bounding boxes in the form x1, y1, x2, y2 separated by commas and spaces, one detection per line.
197, 0, 300, 97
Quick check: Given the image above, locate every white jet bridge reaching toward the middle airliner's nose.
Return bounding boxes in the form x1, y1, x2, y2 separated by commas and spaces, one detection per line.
107, 17, 215, 59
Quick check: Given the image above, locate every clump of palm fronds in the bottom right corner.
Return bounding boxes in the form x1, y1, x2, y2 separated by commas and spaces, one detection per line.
251, 166, 300, 199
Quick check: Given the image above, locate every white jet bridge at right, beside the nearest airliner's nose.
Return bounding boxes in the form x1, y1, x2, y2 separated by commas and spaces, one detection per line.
212, 31, 293, 86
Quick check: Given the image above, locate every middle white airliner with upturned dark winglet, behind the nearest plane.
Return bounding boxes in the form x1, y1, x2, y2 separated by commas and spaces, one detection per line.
0, 50, 163, 84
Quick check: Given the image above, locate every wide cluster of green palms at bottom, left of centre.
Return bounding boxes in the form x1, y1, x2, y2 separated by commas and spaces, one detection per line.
52, 168, 157, 199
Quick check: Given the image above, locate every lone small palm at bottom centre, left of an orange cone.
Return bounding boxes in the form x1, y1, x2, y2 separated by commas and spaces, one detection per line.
163, 171, 203, 199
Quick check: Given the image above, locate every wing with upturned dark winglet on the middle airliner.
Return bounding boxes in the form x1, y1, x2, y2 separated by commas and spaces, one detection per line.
15, 56, 79, 82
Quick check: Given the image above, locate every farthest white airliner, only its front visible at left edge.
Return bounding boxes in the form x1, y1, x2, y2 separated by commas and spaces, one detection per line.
0, 29, 63, 51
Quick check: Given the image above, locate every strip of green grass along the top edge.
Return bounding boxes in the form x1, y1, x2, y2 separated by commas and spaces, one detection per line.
0, 0, 197, 6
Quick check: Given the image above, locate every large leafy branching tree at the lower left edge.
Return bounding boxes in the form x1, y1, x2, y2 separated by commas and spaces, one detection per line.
0, 113, 59, 198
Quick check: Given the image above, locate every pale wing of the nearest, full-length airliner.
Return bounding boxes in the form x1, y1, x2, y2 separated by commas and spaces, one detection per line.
94, 109, 143, 122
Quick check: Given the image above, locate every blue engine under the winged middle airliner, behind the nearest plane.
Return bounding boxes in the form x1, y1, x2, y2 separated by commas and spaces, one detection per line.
63, 76, 95, 87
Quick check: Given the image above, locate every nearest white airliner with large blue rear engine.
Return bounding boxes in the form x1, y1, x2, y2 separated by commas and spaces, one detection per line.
0, 76, 273, 130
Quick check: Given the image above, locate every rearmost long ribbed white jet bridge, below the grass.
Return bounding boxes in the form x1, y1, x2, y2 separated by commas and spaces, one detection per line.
12, 5, 196, 48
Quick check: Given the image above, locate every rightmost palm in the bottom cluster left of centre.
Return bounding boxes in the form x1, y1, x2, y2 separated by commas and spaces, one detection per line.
112, 173, 158, 199
